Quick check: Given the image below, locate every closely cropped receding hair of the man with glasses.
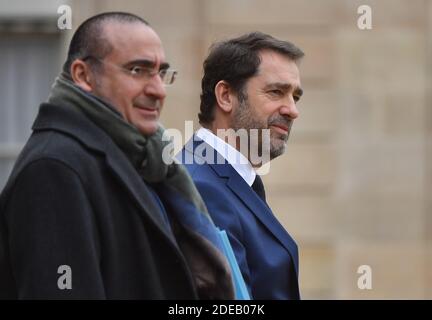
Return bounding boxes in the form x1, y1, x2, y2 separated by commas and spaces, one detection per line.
63, 11, 149, 73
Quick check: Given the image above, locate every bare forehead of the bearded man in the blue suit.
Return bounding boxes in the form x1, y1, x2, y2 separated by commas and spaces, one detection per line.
255, 50, 301, 87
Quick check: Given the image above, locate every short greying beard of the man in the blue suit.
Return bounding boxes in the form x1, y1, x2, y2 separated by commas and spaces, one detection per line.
230, 94, 293, 160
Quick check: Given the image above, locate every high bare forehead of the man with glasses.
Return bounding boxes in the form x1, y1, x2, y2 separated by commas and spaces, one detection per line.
103, 21, 165, 62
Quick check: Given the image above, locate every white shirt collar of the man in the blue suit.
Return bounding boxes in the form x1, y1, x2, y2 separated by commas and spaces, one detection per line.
196, 128, 256, 186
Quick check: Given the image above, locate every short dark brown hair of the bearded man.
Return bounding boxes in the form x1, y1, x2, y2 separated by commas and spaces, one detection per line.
198, 32, 304, 124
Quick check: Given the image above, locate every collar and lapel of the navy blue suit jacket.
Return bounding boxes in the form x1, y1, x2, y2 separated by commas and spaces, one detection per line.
183, 135, 298, 274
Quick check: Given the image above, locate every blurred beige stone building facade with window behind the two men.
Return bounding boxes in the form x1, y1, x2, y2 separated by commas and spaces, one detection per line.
0, 0, 432, 299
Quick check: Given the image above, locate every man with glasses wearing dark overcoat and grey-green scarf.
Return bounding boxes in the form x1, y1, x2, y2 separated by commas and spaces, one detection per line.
0, 12, 233, 299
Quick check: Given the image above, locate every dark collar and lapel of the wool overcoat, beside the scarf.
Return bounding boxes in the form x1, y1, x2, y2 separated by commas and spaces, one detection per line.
32, 103, 175, 245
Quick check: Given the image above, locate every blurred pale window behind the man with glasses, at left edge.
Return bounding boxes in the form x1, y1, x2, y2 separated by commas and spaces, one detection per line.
0, 30, 61, 191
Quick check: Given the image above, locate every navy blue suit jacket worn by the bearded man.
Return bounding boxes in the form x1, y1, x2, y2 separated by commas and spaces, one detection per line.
178, 135, 300, 299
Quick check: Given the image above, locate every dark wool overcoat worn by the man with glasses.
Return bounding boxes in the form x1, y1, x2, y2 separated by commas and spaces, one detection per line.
0, 104, 197, 299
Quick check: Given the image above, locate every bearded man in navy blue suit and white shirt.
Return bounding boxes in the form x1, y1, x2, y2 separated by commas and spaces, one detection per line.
179, 32, 304, 299
